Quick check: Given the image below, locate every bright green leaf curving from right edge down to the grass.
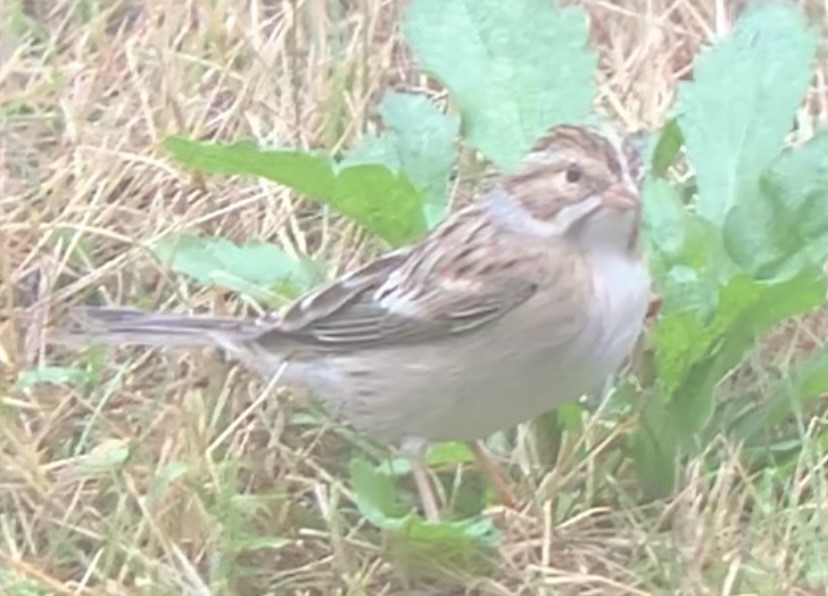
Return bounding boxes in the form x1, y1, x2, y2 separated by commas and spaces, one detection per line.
628, 270, 825, 496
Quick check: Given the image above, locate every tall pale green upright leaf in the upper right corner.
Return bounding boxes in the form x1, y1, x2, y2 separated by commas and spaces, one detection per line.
678, 3, 816, 226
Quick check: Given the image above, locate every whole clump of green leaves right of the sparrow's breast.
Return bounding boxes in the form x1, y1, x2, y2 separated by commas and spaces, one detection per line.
628, 4, 828, 495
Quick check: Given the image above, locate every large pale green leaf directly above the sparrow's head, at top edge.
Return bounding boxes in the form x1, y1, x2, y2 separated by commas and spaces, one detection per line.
403, 0, 596, 170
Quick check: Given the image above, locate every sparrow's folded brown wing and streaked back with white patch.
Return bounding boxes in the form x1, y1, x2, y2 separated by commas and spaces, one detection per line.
258, 207, 536, 349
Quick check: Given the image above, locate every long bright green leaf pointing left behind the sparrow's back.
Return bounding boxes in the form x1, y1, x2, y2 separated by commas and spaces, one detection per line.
164, 137, 426, 245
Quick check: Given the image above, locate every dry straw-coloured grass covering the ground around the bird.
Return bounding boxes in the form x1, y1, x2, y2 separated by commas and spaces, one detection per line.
0, 0, 828, 595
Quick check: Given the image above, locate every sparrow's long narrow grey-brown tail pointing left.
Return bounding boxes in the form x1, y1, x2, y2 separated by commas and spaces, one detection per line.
52, 307, 266, 349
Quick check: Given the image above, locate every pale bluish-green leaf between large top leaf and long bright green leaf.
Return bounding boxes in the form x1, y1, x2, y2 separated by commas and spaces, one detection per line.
345, 92, 460, 227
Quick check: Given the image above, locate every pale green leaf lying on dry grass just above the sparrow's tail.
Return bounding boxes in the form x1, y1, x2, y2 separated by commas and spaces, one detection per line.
152, 234, 323, 303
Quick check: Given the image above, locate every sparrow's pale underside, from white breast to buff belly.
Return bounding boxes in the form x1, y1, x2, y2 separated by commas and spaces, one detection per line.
314, 254, 649, 442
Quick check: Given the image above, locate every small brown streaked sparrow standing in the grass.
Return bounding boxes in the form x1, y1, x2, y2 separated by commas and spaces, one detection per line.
60, 125, 650, 520
